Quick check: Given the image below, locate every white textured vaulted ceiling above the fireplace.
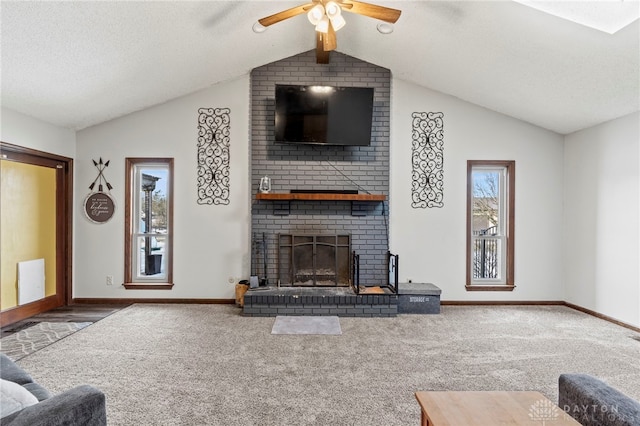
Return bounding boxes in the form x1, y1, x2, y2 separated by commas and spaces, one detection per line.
0, 0, 640, 134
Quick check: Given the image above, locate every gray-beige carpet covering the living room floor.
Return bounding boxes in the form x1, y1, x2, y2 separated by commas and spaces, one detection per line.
11, 304, 640, 426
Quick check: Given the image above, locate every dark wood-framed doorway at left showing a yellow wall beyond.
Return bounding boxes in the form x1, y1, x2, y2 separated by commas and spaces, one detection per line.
0, 142, 73, 327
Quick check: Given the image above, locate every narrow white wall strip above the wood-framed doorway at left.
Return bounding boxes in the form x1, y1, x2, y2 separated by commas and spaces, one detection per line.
0, 108, 76, 158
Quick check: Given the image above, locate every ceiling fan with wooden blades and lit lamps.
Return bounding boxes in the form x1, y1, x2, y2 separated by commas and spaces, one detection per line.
258, 0, 401, 64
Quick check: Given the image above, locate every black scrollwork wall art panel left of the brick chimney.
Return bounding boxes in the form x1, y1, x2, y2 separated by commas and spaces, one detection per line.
198, 108, 231, 204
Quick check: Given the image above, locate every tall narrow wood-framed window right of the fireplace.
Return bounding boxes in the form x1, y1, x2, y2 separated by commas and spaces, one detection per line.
466, 160, 515, 291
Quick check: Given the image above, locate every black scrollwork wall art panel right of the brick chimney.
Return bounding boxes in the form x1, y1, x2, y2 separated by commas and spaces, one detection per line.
411, 112, 444, 209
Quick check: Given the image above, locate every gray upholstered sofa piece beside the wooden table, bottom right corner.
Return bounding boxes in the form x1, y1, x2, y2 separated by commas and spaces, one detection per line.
558, 374, 640, 426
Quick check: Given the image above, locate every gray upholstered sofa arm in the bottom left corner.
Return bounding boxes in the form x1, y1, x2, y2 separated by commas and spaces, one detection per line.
1, 385, 107, 426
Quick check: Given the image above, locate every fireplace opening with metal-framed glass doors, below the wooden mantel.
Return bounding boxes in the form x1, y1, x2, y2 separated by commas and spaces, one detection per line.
278, 234, 351, 287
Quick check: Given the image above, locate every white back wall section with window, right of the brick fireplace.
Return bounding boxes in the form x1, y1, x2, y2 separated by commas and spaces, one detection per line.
389, 79, 564, 301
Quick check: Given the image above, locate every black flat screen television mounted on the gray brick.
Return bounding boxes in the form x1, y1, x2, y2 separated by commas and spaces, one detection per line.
275, 85, 373, 146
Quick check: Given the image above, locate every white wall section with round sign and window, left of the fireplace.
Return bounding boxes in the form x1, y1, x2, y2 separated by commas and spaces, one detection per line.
74, 76, 250, 299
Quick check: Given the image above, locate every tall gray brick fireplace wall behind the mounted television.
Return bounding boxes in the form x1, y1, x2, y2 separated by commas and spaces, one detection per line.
250, 50, 391, 287
